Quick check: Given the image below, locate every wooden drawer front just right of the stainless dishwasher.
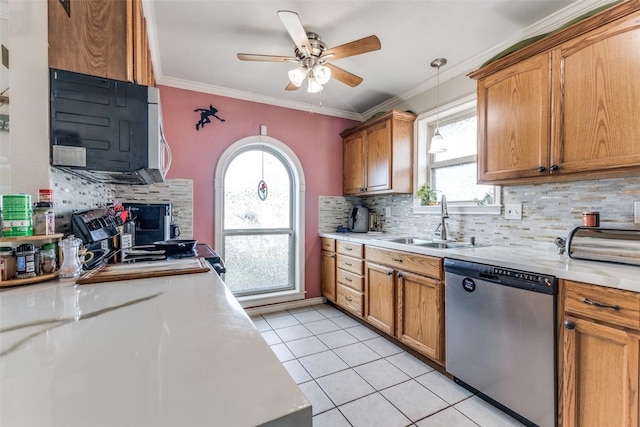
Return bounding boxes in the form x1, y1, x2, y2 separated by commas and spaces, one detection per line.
564, 280, 640, 330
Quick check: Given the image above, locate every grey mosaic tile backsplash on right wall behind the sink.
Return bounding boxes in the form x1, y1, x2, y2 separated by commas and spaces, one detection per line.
318, 177, 640, 251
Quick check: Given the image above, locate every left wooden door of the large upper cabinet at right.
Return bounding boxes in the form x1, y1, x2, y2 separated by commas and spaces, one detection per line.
478, 53, 551, 183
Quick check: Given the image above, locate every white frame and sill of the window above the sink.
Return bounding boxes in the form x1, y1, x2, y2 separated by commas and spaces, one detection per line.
413, 95, 502, 215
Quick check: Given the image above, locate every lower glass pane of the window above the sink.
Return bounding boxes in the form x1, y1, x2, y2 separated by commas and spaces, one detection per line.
431, 162, 493, 204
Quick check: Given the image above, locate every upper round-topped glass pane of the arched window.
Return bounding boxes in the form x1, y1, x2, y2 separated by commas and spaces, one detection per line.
224, 150, 291, 230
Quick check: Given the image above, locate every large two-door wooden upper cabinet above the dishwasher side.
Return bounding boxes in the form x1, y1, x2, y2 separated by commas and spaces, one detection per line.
469, 2, 640, 184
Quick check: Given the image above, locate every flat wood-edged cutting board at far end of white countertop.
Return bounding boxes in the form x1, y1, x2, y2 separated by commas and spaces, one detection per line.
76, 258, 209, 285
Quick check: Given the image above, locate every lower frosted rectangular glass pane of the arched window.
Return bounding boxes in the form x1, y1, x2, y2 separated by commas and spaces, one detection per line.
224, 234, 293, 295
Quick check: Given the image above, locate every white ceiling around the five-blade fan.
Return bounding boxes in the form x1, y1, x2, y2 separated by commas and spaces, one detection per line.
143, 0, 611, 119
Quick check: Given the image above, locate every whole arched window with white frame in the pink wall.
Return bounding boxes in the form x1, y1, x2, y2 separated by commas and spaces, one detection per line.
214, 136, 304, 307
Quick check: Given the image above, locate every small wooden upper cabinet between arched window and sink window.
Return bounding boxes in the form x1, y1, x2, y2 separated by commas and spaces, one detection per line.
341, 111, 416, 195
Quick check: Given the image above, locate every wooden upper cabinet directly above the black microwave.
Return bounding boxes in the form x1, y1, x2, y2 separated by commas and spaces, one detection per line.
48, 0, 155, 86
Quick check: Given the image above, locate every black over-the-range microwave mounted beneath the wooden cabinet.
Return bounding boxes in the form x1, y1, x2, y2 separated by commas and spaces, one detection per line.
49, 68, 171, 184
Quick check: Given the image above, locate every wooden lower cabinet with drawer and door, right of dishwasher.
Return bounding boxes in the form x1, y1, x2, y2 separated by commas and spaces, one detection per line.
561, 281, 640, 427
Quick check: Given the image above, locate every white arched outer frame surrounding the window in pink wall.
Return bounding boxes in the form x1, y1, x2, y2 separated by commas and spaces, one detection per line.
214, 135, 306, 308
